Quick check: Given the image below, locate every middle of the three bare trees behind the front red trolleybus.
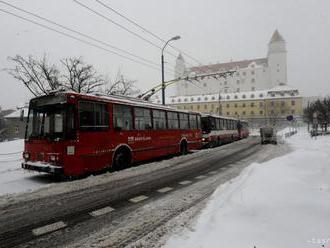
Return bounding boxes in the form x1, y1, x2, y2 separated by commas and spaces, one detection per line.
61, 58, 105, 93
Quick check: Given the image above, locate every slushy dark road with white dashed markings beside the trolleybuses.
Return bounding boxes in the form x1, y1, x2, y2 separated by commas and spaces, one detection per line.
0, 138, 287, 247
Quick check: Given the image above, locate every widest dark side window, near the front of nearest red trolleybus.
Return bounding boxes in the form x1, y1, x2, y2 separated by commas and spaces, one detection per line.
79, 101, 109, 131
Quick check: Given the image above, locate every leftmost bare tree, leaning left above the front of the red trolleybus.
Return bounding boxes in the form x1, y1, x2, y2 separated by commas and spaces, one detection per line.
6, 55, 60, 96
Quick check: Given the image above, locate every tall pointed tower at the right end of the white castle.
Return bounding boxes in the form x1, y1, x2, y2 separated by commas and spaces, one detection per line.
267, 30, 287, 87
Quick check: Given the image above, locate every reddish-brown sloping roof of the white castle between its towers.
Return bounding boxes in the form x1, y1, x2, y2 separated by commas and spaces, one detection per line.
189, 58, 268, 73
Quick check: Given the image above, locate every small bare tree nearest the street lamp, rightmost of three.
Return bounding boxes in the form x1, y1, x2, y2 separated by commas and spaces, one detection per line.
105, 70, 139, 96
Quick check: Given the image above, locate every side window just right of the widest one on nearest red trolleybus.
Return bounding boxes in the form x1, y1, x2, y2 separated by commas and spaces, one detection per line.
113, 104, 133, 131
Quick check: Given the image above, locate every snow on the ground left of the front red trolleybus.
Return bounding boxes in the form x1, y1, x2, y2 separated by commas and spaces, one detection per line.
0, 139, 55, 195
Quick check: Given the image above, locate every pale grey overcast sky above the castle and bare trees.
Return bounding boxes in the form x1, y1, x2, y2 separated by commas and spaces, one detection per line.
0, 0, 330, 107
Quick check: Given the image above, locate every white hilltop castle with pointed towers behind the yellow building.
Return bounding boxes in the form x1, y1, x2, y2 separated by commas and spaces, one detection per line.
175, 30, 287, 96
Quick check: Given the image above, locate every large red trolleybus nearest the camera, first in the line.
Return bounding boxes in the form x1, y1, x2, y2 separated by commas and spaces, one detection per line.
22, 92, 202, 176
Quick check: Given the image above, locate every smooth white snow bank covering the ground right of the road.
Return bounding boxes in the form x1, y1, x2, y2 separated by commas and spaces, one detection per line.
165, 131, 330, 248
